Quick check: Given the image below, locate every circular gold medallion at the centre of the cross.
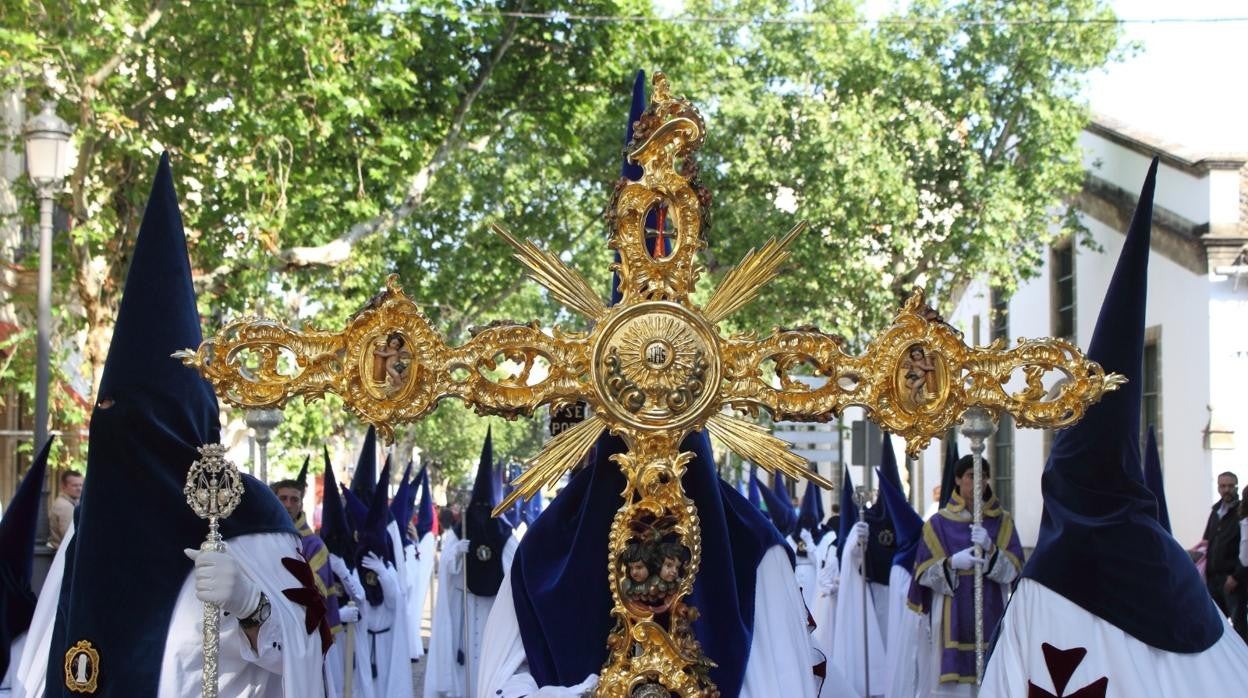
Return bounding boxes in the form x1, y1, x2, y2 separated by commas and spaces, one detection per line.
592, 301, 720, 430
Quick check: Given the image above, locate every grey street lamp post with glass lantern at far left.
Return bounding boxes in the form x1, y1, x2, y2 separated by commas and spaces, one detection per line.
25, 101, 72, 452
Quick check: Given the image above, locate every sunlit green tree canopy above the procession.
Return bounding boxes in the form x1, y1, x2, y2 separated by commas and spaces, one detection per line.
0, 0, 1119, 489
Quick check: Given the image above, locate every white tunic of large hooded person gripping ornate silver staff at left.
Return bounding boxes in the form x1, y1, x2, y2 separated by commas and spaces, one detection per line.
19, 533, 324, 698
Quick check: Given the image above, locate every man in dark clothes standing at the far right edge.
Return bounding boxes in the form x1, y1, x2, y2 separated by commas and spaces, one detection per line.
1204, 472, 1248, 637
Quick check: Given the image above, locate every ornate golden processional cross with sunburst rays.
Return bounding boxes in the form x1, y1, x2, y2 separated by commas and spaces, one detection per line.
178, 74, 1121, 698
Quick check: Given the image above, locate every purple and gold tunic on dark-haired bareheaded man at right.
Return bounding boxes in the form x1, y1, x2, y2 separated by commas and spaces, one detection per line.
907, 493, 1022, 683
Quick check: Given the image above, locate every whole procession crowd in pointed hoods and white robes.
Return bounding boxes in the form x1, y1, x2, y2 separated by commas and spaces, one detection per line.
0, 76, 1248, 698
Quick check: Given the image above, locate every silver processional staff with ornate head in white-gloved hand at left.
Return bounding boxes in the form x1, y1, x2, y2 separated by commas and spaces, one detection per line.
182, 443, 243, 698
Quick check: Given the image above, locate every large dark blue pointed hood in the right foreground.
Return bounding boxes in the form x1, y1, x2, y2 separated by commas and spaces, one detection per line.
1023, 159, 1226, 653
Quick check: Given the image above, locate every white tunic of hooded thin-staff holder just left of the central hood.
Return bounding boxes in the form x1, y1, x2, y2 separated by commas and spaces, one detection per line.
424, 531, 518, 698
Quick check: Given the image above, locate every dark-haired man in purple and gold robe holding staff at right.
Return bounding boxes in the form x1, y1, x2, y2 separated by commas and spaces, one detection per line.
909, 456, 1022, 698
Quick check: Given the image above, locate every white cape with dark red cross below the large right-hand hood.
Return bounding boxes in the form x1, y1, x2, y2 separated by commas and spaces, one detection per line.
980, 579, 1248, 698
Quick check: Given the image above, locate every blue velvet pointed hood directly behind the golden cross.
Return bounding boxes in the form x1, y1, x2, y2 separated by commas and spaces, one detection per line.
510, 71, 791, 696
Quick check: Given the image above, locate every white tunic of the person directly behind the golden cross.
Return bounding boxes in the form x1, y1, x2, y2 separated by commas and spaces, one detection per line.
477, 546, 841, 698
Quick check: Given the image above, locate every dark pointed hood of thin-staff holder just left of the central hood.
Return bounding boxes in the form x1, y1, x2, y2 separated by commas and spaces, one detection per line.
464, 428, 512, 597
